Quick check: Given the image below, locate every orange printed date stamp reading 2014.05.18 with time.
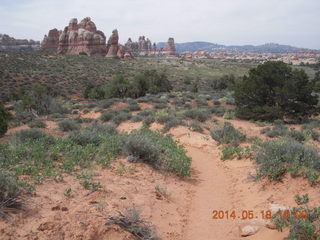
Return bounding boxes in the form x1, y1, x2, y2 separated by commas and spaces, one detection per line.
212, 210, 308, 220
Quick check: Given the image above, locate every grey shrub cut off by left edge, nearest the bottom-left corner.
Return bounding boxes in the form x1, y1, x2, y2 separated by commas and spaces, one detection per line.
0, 169, 22, 216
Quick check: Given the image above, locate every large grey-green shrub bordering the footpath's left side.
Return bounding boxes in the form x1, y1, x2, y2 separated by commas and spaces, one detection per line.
124, 128, 191, 176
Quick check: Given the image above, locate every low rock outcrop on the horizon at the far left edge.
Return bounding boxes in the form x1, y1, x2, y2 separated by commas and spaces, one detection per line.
0, 34, 40, 51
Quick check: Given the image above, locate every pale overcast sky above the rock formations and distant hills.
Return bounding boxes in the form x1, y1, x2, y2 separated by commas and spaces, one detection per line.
0, 0, 320, 49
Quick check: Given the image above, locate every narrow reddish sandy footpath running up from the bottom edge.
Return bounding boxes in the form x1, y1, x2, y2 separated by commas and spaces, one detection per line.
183, 146, 235, 240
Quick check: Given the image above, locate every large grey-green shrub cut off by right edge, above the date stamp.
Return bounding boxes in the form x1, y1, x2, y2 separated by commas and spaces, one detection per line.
254, 138, 320, 183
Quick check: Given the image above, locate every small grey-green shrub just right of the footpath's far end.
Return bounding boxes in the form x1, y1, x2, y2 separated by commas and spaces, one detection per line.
210, 122, 246, 144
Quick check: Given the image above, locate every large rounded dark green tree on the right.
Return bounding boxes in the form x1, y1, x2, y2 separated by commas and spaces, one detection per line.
234, 62, 317, 120
